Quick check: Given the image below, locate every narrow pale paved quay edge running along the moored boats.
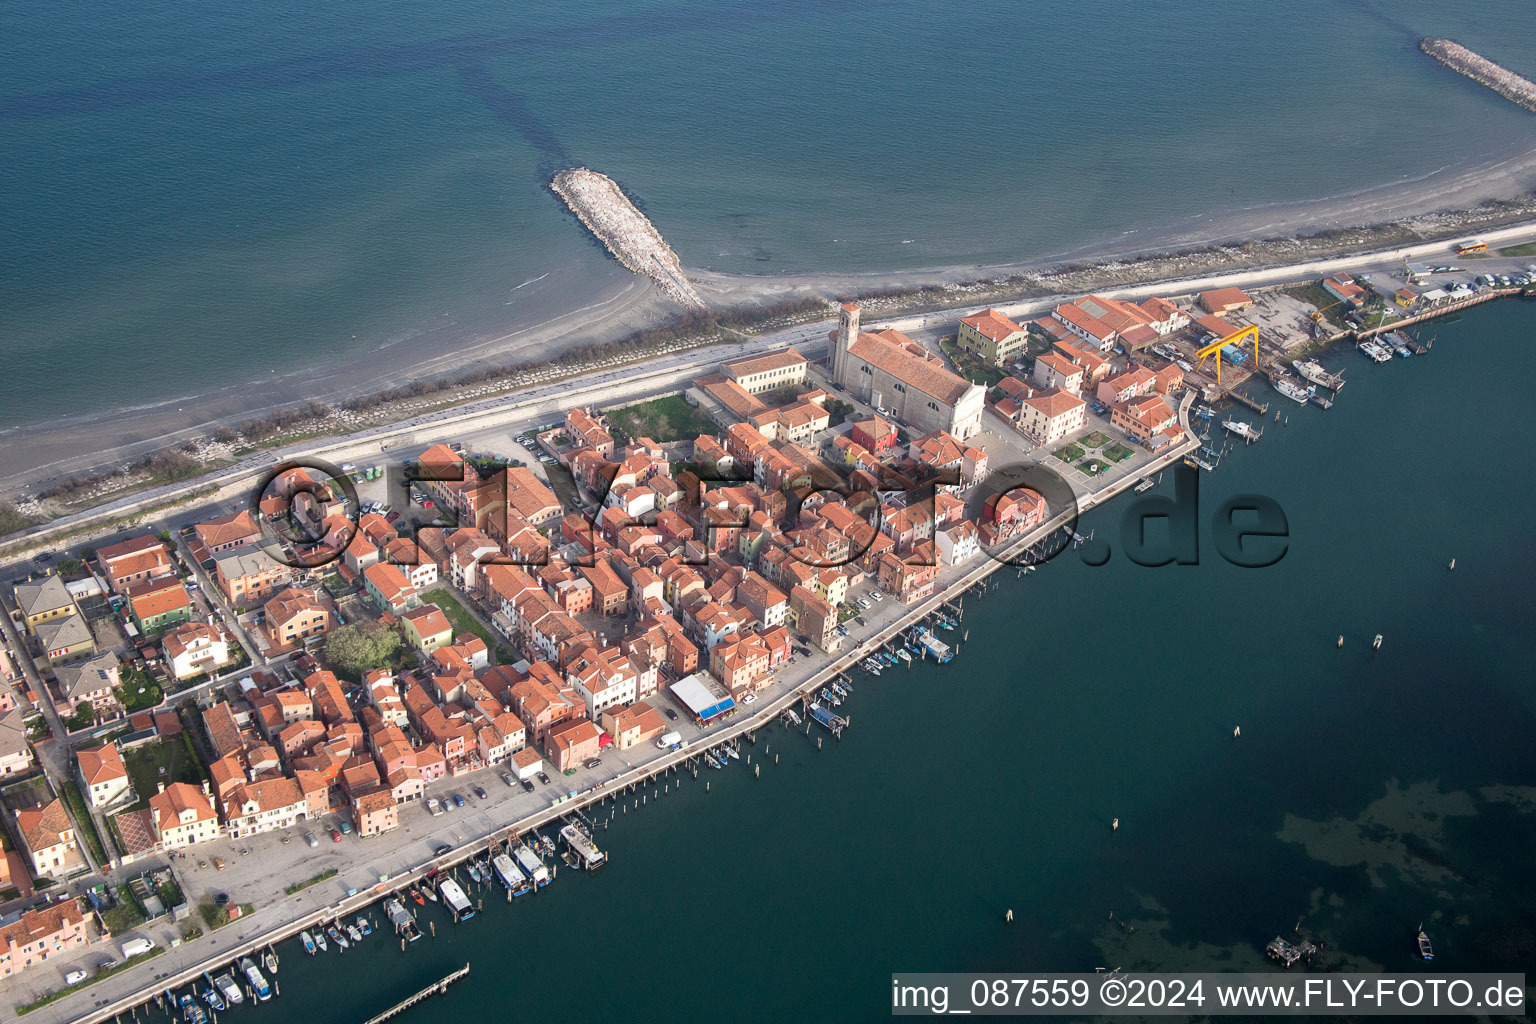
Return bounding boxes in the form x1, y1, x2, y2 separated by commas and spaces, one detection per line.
44, 405, 1200, 1024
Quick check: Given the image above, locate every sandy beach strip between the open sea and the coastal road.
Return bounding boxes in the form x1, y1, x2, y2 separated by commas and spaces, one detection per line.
0, 135, 1536, 496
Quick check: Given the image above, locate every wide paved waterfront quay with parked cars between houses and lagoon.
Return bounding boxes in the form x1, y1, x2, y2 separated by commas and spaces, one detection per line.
28, 393, 1198, 1024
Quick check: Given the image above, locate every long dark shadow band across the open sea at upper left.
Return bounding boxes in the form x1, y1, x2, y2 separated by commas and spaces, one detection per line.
0, 0, 829, 118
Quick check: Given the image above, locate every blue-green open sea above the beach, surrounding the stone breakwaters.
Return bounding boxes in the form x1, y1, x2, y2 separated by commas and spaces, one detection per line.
0, 0, 1536, 430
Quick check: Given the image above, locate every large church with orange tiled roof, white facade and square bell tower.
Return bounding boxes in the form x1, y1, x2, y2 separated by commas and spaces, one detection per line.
833, 302, 986, 441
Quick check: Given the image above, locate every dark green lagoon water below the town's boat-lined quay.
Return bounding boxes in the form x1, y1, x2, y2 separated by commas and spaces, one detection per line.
105, 301, 1536, 1024
